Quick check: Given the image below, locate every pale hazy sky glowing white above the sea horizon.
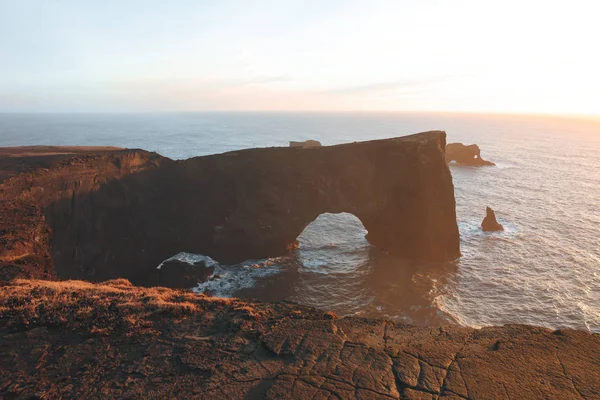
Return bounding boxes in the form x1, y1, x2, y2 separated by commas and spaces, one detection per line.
0, 0, 600, 115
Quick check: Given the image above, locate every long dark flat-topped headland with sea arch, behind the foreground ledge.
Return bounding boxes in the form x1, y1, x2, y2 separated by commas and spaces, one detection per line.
0, 131, 460, 283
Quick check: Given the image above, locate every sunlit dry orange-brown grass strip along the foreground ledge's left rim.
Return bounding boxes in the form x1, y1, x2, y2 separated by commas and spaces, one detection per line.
0, 279, 256, 334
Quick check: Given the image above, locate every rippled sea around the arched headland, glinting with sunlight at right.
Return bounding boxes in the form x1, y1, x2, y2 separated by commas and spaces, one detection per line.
0, 112, 600, 332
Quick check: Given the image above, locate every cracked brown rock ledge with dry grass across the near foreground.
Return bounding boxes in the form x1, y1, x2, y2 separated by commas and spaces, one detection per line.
0, 280, 600, 400
